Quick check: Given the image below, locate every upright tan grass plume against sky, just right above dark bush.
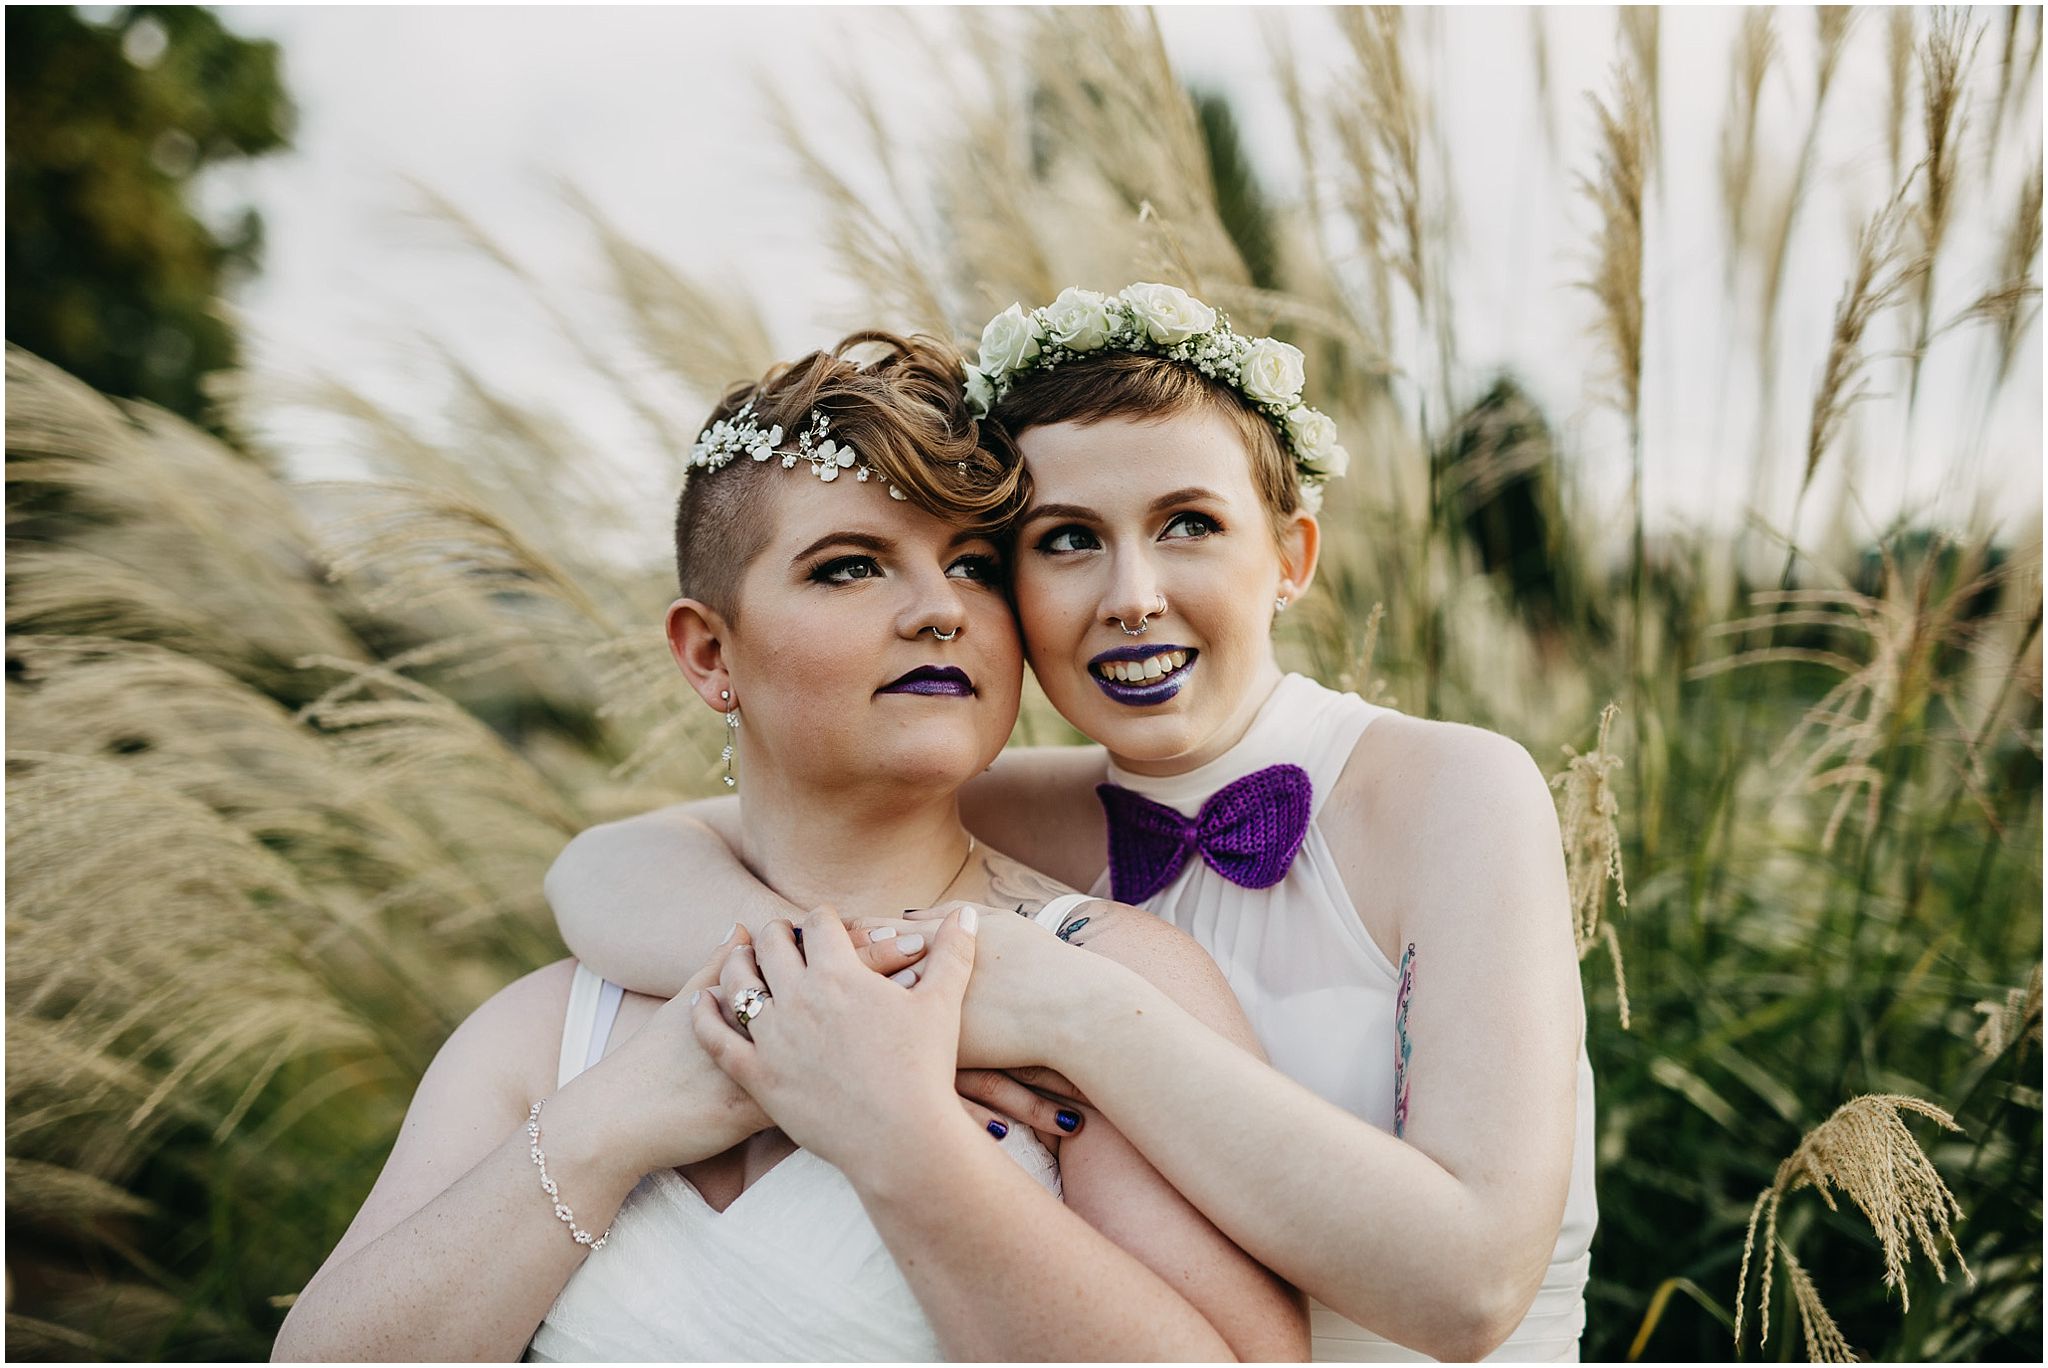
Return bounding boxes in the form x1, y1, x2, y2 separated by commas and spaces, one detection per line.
1577, 63, 1651, 428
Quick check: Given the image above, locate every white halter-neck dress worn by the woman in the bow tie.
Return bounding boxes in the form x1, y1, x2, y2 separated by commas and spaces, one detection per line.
1094, 674, 1597, 1362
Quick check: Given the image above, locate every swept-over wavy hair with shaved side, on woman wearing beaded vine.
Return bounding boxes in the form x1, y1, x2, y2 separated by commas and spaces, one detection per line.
676, 332, 1024, 623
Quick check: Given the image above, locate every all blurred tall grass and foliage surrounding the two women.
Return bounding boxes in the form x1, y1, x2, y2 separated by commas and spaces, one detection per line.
6, 8, 2042, 1360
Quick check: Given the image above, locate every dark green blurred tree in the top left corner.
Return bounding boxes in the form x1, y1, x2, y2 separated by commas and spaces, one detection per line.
6, 4, 295, 438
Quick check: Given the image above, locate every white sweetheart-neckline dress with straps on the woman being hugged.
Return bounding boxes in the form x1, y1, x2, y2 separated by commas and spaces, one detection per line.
526, 965, 1059, 1364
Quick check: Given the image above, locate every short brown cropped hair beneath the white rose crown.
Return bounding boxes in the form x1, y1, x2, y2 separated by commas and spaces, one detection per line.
981, 352, 1300, 537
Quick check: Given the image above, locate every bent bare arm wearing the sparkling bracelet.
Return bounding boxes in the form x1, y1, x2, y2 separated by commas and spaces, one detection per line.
270, 960, 766, 1362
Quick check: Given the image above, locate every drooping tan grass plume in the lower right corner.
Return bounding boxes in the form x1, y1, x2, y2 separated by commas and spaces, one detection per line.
1735, 1094, 1976, 1348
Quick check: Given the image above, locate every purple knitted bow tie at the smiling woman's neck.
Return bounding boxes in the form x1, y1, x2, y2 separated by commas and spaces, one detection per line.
1096, 764, 1315, 903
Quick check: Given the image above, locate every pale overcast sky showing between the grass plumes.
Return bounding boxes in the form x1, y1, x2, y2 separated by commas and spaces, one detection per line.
195, 6, 2042, 548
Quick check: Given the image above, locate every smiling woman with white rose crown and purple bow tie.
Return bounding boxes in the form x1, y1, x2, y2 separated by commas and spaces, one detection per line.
549, 285, 1595, 1360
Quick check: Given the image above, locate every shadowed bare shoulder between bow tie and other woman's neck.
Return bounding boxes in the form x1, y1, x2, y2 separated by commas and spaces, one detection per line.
961, 745, 1108, 889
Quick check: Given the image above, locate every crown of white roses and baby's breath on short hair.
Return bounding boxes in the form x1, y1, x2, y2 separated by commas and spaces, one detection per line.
967, 283, 1352, 512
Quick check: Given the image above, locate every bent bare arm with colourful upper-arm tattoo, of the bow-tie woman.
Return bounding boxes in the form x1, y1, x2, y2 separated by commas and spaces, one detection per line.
983, 729, 1583, 1360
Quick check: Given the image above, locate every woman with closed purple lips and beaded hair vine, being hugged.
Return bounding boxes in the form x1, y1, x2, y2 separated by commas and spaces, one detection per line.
274, 334, 1307, 1362
